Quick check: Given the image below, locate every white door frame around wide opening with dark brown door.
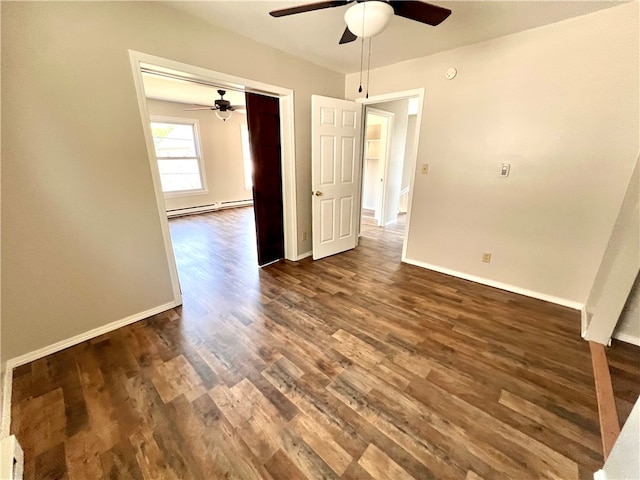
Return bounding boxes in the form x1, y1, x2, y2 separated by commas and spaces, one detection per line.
129, 50, 298, 305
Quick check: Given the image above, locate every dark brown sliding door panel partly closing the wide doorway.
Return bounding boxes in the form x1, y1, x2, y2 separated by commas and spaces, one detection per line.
246, 93, 284, 265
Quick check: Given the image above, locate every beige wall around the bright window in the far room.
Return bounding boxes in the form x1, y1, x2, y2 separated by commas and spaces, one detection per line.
147, 99, 252, 210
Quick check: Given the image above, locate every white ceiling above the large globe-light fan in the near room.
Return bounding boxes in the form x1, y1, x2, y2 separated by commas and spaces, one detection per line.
164, 0, 624, 73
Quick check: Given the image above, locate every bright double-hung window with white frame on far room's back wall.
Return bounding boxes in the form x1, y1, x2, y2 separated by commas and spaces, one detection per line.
151, 119, 206, 193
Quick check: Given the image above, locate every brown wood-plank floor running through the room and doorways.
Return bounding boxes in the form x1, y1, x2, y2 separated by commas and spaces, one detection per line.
11, 208, 640, 480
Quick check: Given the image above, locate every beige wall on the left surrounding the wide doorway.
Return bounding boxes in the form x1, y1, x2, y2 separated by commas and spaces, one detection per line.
1, 2, 344, 359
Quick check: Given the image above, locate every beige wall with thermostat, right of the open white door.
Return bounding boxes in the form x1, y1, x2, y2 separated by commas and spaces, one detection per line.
345, 2, 639, 303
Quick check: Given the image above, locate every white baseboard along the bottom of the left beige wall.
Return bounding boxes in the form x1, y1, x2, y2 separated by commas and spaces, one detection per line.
2, 301, 178, 438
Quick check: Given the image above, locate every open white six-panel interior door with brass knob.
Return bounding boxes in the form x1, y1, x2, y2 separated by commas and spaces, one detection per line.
311, 95, 362, 260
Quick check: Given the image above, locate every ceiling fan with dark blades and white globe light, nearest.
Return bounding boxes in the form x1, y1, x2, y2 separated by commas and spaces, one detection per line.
269, 0, 451, 44
